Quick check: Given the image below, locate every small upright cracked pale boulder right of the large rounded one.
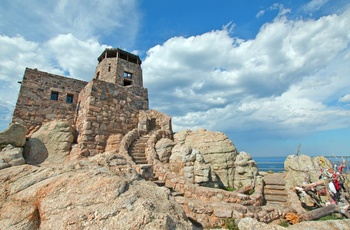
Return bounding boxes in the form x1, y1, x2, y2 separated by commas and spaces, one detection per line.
234, 152, 258, 188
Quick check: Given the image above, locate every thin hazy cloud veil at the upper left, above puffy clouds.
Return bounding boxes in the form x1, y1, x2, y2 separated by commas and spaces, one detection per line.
0, 0, 139, 43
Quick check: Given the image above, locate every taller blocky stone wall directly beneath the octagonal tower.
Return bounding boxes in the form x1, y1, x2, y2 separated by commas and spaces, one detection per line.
76, 79, 148, 155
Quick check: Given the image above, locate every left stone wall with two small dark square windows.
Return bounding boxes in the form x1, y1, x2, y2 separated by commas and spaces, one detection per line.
12, 68, 87, 133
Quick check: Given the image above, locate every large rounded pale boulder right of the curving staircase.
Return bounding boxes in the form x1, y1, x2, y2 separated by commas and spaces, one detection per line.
170, 129, 237, 187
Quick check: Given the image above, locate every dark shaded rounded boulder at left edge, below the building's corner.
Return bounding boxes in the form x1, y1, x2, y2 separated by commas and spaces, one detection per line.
0, 123, 27, 147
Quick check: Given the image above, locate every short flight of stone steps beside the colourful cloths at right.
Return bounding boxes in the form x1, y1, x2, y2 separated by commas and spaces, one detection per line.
264, 173, 288, 205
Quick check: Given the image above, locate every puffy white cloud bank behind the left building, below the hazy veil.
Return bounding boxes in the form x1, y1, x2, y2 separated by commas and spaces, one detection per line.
0, 34, 107, 128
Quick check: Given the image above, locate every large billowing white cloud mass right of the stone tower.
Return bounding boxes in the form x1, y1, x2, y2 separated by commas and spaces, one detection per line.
143, 10, 350, 135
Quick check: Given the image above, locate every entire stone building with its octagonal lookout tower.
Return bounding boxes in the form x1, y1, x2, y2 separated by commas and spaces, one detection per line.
12, 49, 170, 155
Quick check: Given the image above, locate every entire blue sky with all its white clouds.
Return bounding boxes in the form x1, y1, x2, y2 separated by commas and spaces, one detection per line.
0, 0, 350, 157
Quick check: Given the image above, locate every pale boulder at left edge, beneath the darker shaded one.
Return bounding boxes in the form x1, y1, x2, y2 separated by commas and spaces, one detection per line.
0, 144, 25, 169
